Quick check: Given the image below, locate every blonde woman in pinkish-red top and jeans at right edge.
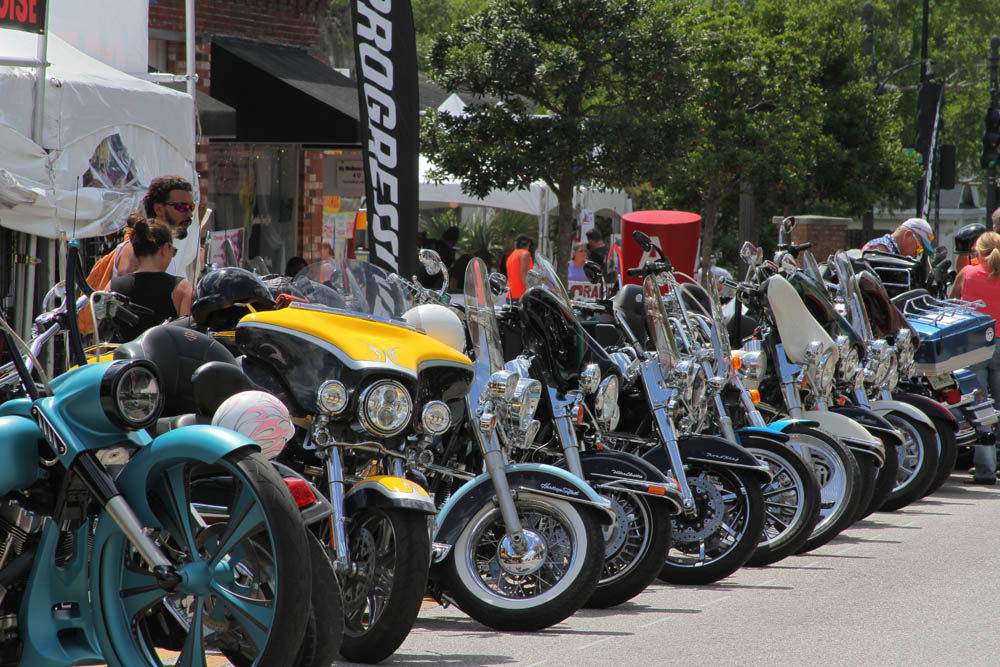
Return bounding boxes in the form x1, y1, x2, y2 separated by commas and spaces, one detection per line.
951, 232, 1000, 485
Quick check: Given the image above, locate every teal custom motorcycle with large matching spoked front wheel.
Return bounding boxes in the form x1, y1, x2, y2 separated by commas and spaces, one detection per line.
0, 246, 312, 667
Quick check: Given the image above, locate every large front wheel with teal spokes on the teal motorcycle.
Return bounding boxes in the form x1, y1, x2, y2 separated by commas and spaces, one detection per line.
94, 450, 311, 666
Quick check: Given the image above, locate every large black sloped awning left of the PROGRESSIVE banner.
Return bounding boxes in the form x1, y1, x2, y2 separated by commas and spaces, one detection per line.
211, 37, 359, 144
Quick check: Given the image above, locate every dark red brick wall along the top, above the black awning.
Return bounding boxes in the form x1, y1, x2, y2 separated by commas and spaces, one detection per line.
149, 0, 325, 49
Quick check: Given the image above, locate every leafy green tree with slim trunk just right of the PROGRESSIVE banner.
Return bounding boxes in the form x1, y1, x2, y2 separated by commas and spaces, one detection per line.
421, 0, 691, 271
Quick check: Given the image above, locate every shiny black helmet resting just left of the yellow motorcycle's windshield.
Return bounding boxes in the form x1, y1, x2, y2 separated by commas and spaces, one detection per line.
191, 266, 274, 331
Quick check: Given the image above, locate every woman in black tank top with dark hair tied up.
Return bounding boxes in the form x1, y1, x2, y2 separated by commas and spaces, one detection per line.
110, 218, 193, 342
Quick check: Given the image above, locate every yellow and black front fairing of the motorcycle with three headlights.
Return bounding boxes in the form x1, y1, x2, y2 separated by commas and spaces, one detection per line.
236, 304, 472, 414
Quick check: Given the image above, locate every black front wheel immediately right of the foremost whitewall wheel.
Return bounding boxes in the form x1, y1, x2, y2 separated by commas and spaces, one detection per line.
584, 491, 670, 609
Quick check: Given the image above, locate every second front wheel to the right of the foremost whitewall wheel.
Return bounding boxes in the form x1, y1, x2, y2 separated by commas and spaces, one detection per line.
660, 462, 764, 584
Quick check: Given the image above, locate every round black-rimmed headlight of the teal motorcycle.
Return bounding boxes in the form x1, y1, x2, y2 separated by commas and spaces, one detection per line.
100, 359, 164, 430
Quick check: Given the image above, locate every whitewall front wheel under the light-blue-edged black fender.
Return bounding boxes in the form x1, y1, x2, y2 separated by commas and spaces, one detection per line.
443, 491, 604, 632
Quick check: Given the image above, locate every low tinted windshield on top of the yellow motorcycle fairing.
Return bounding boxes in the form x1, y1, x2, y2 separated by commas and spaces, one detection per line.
292, 258, 410, 319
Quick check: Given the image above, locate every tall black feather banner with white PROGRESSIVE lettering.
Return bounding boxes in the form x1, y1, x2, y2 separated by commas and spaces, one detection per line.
351, 0, 419, 276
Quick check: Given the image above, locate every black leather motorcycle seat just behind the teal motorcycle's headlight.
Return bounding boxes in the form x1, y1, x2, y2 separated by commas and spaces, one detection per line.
114, 324, 239, 416
